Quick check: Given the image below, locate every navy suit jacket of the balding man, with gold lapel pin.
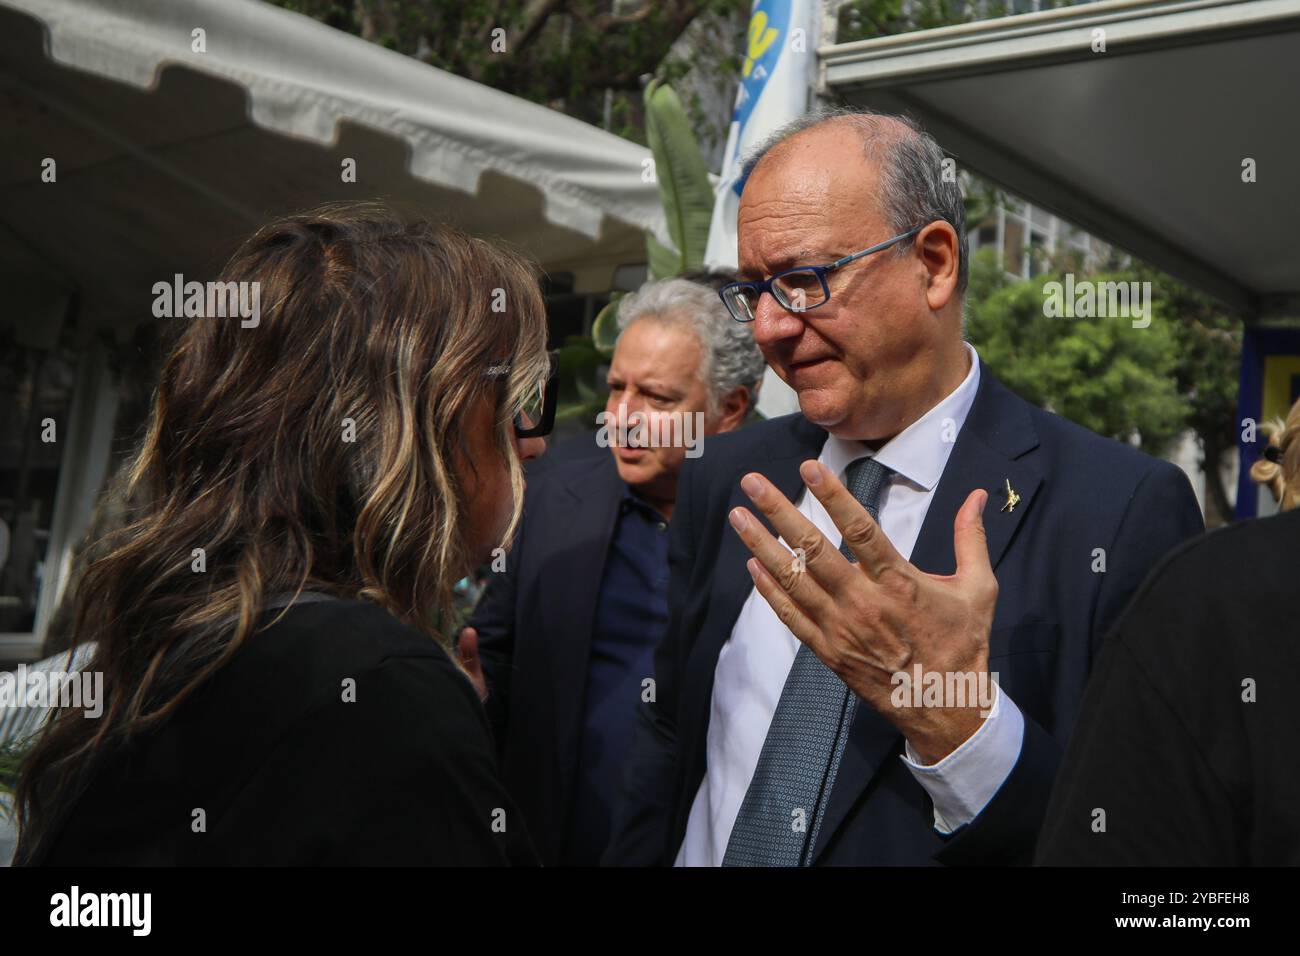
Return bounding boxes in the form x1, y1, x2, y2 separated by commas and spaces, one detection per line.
605, 364, 1204, 865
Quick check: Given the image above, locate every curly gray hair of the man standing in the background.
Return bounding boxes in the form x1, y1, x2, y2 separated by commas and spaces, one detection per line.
619, 278, 766, 418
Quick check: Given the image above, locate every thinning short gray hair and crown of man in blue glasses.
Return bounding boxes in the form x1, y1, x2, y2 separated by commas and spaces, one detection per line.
742, 107, 970, 295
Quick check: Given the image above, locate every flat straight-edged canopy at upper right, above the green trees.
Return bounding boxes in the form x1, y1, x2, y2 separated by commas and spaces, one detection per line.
819, 0, 1300, 321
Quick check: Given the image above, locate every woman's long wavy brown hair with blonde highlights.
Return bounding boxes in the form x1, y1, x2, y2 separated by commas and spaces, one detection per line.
18, 204, 547, 860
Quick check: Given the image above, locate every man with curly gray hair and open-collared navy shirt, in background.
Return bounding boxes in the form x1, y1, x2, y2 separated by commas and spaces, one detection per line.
460, 280, 763, 865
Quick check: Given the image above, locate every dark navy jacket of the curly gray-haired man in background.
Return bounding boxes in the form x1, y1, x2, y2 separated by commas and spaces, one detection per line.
468, 437, 627, 865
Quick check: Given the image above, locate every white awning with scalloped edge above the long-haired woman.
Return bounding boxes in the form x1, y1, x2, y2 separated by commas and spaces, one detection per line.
0, 0, 666, 321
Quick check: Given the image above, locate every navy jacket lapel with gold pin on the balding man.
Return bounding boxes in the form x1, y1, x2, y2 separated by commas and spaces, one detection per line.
814, 362, 1043, 861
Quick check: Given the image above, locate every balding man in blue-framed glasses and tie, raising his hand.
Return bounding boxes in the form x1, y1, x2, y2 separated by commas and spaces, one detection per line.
606, 113, 1203, 865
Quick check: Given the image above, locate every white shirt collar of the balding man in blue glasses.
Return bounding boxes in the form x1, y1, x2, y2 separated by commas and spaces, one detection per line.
822, 342, 979, 492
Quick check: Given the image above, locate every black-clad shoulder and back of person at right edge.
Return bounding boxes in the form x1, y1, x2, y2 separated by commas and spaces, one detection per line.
1037, 511, 1300, 865
